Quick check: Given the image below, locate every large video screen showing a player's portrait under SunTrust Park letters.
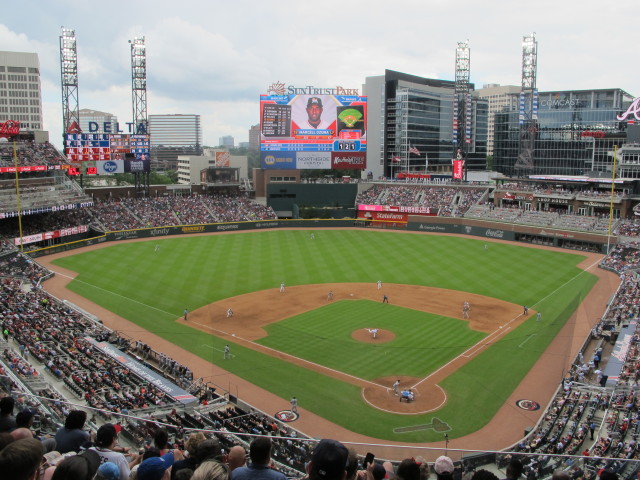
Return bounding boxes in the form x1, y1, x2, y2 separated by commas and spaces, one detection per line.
260, 95, 367, 169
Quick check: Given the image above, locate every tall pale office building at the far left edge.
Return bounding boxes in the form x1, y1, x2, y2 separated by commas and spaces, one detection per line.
0, 51, 44, 130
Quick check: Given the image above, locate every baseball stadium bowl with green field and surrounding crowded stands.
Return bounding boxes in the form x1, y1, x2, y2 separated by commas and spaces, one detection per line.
0, 135, 640, 478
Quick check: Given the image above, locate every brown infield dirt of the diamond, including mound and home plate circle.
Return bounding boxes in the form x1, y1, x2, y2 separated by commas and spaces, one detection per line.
181, 283, 524, 414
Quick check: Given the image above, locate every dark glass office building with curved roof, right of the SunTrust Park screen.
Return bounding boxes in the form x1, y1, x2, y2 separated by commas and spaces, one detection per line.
363, 70, 488, 179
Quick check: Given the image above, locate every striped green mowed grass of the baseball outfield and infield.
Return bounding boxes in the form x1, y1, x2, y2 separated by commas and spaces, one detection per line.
54, 230, 596, 442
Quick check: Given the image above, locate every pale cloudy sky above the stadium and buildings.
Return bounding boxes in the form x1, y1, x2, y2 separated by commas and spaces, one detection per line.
0, 0, 640, 147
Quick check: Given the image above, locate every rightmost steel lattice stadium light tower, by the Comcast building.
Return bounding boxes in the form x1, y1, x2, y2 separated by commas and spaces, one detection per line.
515, 32, 538, 171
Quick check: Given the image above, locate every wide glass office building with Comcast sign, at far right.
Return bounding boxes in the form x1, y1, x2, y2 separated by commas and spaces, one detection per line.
493, 88, 633, 176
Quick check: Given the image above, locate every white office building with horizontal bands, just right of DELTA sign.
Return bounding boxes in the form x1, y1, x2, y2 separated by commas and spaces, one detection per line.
149, 114, 202, 169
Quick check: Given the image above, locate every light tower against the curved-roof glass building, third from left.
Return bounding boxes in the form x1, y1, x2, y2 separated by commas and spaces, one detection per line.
452, 40, 471, 177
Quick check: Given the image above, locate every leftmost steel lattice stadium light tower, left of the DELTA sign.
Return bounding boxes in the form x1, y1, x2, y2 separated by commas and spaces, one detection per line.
60, 27, 80, 136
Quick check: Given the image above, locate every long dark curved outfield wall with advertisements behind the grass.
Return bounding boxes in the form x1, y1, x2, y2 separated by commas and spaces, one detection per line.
28, 215, 616, 257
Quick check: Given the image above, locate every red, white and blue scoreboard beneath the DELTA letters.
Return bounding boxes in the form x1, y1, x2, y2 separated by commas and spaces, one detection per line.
65, 133, 151, 175
